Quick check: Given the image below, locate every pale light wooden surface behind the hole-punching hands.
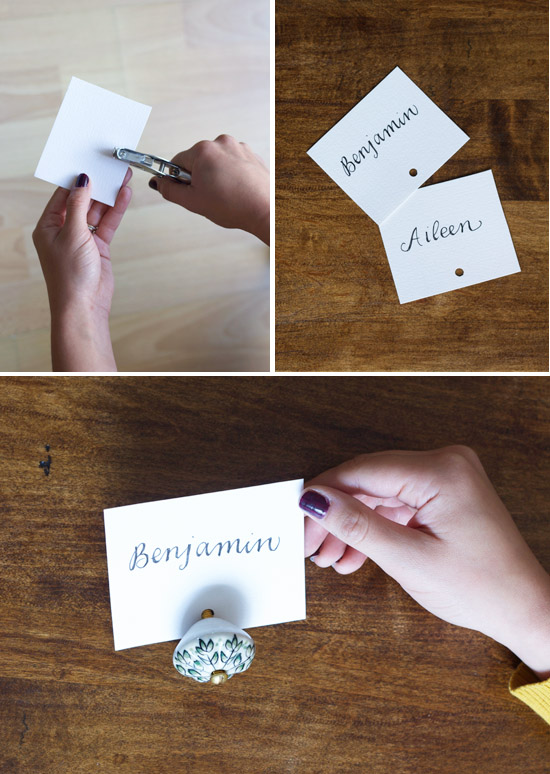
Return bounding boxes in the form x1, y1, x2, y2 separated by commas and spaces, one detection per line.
0, 0, 269, 371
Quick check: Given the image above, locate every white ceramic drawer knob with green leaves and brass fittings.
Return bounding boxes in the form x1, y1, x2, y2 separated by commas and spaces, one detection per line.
173, 610, 255, 685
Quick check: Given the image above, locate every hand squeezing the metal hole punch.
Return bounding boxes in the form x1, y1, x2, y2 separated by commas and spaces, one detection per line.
149, 134, 269, 244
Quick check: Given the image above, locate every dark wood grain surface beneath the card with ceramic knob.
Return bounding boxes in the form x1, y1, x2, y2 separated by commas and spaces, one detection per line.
0, 377, 550, 774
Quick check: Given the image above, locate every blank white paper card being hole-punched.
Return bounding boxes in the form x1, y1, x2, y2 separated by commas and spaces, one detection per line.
34, 77, 151, 206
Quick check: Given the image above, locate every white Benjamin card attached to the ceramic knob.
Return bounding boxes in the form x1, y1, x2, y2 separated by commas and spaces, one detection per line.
104, 479, 306, 650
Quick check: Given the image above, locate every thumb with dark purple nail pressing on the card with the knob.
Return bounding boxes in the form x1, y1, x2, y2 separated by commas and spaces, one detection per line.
300, 485, 430, 577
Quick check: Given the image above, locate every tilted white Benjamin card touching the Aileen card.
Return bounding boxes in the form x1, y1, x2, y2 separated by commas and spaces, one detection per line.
308, 67, 469, 224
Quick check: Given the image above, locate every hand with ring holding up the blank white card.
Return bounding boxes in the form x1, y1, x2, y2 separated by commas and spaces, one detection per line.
32, 169, 132, 371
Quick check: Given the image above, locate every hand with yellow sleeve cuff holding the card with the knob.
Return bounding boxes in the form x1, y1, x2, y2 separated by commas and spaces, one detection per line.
300, 446, 550, 679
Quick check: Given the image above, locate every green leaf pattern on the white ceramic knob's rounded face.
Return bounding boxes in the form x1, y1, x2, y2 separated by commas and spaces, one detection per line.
174, 633, 256, 683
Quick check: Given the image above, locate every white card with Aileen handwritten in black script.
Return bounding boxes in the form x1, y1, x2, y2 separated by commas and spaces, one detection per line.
380, 170, 521, 304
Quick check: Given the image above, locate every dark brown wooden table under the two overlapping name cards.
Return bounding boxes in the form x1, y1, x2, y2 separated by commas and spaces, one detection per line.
275, 0, 548, 371
